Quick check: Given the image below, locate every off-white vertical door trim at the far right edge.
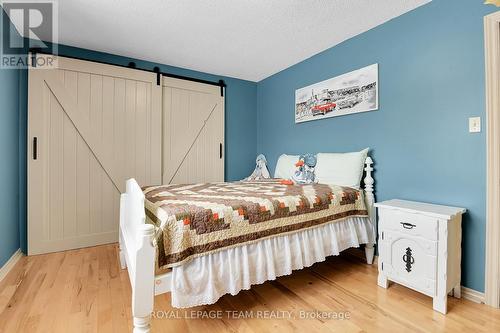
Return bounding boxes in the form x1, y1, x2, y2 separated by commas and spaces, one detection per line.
484, 11, 500, 308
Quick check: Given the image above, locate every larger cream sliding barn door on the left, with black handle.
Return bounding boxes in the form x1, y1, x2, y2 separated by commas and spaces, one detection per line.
28, 55, 162, 254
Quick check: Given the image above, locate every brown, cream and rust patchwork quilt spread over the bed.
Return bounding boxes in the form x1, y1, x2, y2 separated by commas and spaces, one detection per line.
143, 179, 368, 269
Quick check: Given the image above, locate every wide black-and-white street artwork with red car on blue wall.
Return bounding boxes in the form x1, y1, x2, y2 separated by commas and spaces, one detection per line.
295, 64, 378, 123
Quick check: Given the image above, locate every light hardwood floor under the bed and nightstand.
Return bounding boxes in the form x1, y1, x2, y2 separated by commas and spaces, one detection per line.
0, 244, 500, 333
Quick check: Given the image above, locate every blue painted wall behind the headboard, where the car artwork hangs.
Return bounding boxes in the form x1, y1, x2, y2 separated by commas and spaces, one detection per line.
257, 0, 495, 291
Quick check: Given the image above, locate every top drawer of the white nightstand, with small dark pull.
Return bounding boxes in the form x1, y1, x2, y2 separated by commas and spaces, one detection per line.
379, 209, 439, 240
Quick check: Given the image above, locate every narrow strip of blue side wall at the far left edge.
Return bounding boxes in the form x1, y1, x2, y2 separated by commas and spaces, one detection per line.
0, 9, 19, 267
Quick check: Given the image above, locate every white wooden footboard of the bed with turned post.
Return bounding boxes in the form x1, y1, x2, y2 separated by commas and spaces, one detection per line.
120, 179, 155, 333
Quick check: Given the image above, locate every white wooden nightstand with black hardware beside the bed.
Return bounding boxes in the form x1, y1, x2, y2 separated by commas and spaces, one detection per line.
375, 200, 466, 313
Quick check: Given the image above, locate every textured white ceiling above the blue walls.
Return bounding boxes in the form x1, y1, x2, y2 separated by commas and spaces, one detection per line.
7, 0, 429, 81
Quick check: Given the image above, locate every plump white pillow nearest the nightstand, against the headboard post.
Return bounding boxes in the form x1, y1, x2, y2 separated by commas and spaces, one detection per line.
315, 148, 369, 189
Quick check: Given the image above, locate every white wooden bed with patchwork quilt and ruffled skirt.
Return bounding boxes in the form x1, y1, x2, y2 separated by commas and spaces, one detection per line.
119, 157, 376, 332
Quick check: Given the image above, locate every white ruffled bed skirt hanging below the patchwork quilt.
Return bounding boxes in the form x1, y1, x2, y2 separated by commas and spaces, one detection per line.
171, 217, 374, 308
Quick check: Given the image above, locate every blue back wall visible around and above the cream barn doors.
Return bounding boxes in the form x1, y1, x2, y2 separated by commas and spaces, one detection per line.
19, 45, 257, 251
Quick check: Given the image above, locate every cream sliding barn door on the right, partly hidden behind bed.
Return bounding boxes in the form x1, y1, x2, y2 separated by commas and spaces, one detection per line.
163, 77, 224, 184
